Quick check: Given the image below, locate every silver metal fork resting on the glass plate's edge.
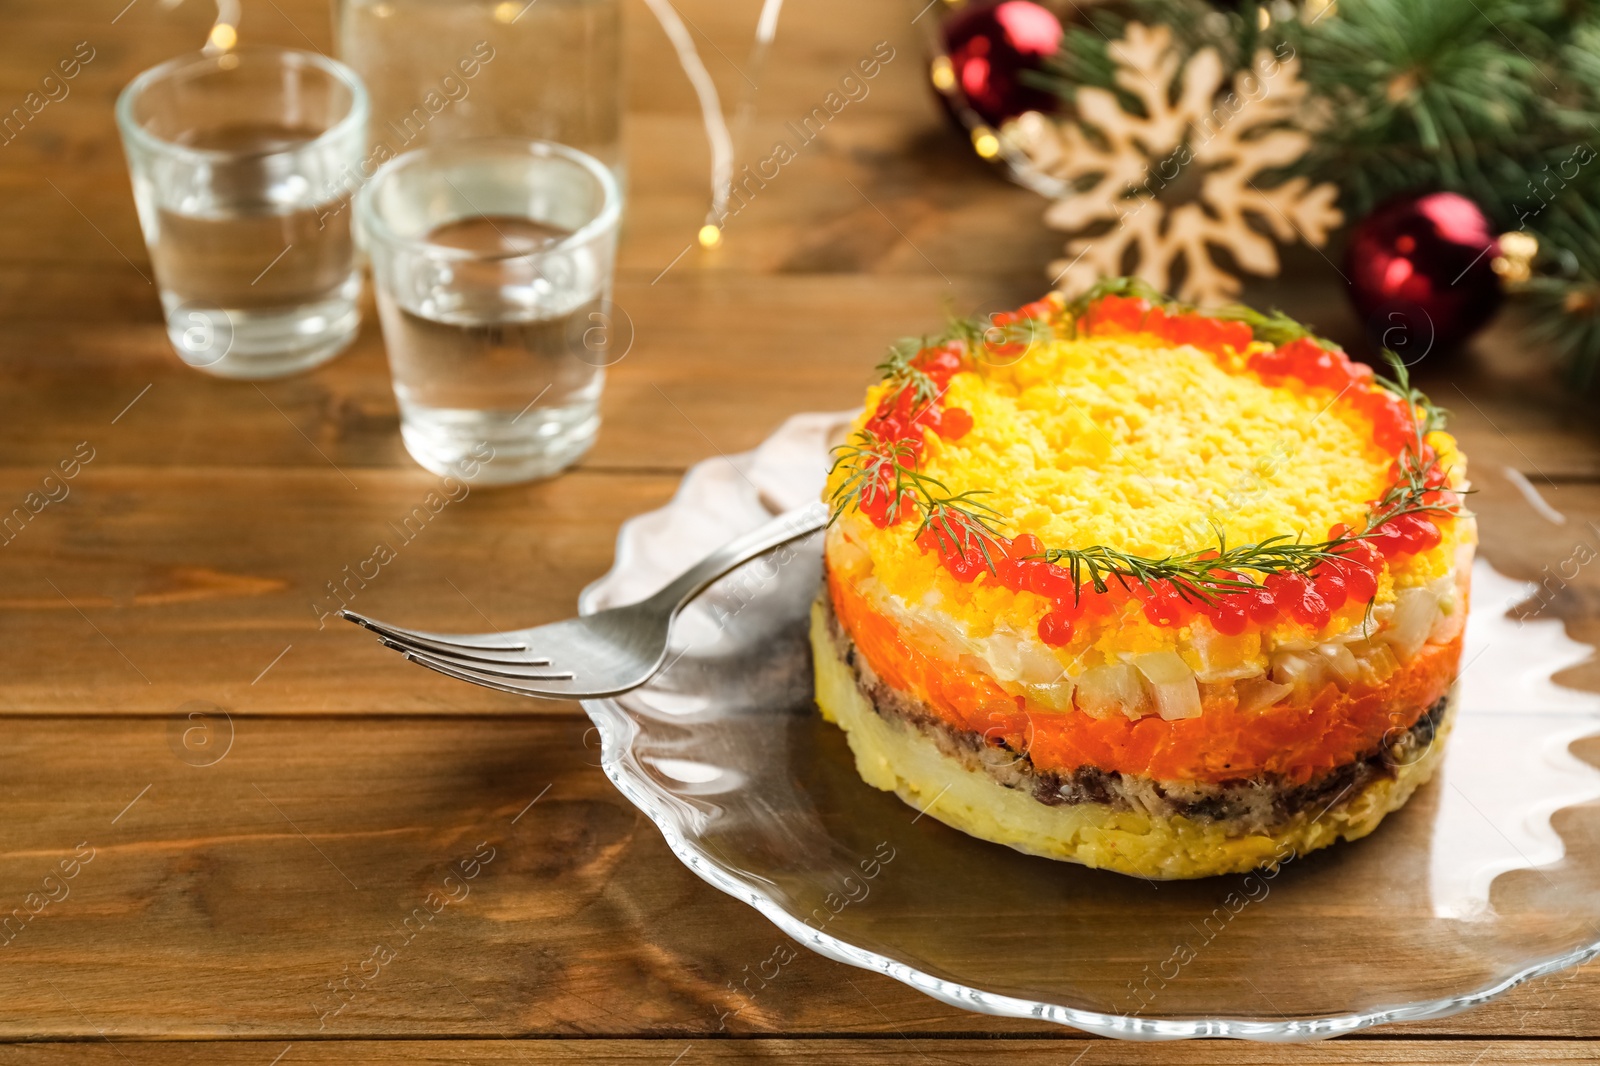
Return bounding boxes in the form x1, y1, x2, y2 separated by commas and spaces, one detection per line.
339, 503, 827, 699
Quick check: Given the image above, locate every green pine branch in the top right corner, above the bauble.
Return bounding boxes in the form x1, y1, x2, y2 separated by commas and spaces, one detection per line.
1291, 0, 1600, 219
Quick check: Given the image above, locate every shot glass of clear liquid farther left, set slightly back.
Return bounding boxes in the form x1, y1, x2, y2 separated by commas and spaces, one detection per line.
117, 48, 366, 378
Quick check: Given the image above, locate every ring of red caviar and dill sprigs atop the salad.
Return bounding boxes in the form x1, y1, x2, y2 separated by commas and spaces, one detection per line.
832, 279, 1461, 643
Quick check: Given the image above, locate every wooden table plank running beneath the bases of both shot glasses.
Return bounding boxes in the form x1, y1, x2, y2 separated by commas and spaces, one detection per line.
0, 274, 1600, 473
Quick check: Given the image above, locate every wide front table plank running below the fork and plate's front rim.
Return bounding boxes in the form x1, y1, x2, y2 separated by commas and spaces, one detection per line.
0, 714, 1600, 1037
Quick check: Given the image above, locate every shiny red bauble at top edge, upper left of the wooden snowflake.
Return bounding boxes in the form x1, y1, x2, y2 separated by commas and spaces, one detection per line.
942, 0, 1062, 126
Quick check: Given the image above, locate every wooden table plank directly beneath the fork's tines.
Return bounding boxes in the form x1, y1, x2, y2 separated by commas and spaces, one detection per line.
0, 467, 677, 714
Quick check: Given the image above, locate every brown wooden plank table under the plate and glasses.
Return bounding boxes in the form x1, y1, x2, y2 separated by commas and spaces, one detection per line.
0, 0, 1600, 1066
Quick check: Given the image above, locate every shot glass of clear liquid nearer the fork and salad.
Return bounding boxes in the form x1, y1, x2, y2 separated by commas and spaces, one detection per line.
357, 139, 619, 483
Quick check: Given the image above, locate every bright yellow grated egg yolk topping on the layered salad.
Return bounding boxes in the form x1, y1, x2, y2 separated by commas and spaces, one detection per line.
829, 335, 1462, 648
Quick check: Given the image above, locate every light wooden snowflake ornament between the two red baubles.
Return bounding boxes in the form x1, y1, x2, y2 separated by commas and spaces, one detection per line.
1005, 22, 1342, 304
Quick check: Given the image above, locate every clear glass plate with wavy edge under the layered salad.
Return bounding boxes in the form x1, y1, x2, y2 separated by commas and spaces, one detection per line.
579, 415, 1600, 1040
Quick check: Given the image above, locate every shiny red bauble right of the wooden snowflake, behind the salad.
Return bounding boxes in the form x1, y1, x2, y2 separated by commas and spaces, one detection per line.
1344, 192, 1502, 356
